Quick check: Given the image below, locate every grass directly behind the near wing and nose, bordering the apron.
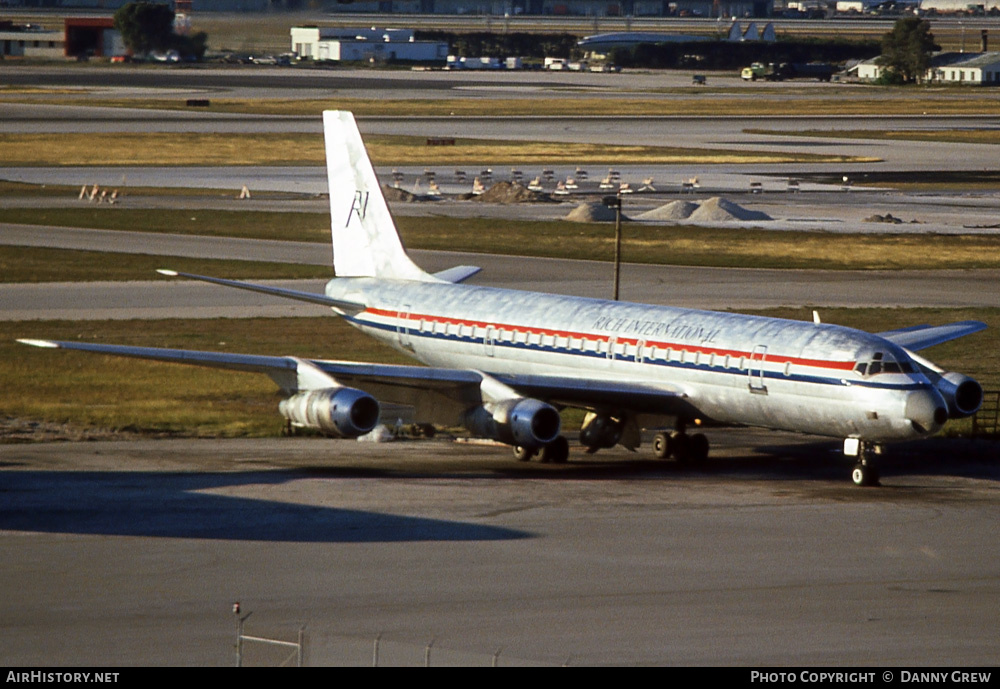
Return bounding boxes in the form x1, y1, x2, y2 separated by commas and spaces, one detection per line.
0, 309, 1000, 442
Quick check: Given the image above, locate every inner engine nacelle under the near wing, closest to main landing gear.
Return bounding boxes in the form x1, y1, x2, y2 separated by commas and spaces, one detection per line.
464, 397, 562, 450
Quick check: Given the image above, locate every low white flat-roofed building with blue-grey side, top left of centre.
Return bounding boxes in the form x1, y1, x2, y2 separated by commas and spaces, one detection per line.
291, 26, 448, 63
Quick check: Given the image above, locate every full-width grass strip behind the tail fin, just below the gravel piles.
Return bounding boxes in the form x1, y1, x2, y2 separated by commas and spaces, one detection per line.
0, 208, 1000, 282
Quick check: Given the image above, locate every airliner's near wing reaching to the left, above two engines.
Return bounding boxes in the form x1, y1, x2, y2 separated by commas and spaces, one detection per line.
18, 339, 692, 424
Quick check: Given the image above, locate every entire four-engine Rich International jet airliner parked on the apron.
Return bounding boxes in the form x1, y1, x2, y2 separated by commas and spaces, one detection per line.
24, 112, 986, 485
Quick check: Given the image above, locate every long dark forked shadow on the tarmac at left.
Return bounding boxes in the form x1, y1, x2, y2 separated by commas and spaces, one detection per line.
0, 471, 532, 543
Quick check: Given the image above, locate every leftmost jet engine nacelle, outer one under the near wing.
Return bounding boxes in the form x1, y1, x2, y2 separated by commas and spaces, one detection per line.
278, 387, 379, 438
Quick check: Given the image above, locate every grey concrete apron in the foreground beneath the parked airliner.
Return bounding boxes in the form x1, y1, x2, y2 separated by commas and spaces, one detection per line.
0, 431, 1000, 668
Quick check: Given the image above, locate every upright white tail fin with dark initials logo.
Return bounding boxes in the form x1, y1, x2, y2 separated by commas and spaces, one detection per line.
323, 110, 437, 282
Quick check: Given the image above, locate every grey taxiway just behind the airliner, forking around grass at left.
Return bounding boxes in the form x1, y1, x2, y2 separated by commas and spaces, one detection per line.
0, 224, 1000, 321
